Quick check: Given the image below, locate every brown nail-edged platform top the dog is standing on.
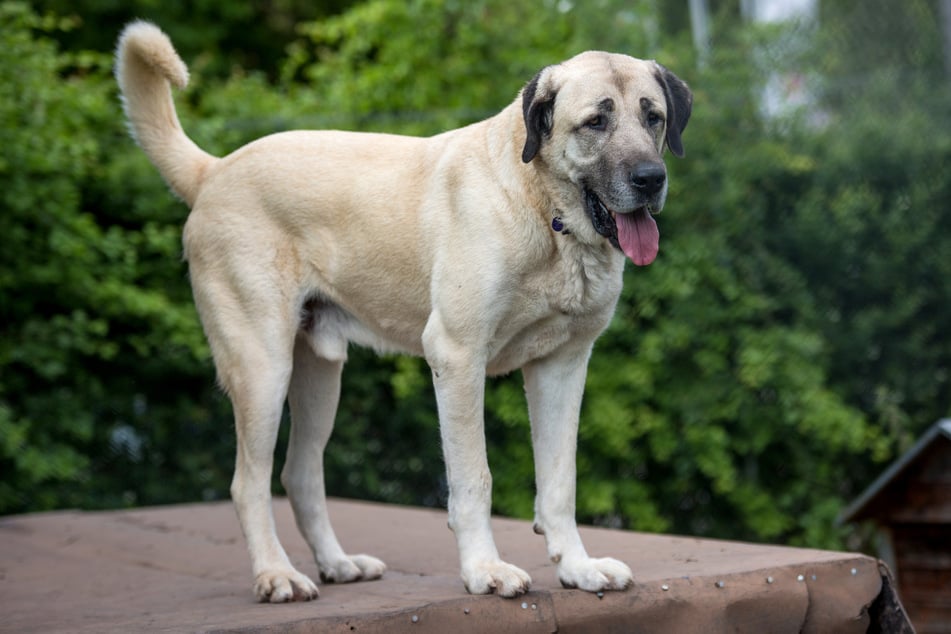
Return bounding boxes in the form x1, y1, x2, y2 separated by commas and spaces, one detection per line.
0, 499, 882, 634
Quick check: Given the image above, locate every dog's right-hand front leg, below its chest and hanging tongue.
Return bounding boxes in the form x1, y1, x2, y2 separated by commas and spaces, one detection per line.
522, 345, 634, 592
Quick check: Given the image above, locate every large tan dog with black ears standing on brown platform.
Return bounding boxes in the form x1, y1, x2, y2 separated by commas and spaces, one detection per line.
116, 22, 692, 602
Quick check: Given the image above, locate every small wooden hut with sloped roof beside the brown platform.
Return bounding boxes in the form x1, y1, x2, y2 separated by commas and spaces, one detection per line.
842, 419, 951, 634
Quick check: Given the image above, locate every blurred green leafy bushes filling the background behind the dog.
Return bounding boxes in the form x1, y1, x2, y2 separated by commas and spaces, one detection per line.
0, 0, 951, 548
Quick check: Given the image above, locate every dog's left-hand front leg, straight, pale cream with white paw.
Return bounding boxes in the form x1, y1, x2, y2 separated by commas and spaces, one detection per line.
424, 322, 531, 597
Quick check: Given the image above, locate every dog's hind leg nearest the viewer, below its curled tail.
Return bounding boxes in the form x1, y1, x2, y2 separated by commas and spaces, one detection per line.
189, 262, 317, 603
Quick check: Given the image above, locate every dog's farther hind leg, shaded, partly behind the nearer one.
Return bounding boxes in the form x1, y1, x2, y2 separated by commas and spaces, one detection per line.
281, 334, 386, 583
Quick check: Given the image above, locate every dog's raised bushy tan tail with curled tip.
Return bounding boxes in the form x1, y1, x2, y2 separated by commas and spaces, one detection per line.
115, 21, 217, 207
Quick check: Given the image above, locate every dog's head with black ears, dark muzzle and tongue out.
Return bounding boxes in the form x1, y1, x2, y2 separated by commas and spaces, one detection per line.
522, 51, 693, 265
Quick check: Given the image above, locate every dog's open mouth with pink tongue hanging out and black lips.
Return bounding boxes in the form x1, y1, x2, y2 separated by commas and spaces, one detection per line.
584, 187, 660, 266
